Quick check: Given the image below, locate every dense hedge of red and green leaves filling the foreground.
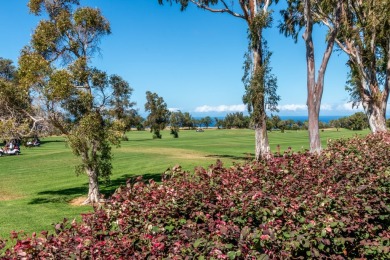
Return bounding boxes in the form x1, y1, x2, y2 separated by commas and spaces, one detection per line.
0, 133, 390, 259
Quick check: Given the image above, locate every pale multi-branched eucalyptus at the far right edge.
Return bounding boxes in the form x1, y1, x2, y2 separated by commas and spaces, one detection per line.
336, 0, 390, 133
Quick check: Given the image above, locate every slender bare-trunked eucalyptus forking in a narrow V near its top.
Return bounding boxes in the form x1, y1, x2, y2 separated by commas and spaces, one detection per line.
279, 0, 341, 153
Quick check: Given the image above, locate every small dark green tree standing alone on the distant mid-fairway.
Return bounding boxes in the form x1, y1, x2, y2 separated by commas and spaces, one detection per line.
145, 91, 170, 139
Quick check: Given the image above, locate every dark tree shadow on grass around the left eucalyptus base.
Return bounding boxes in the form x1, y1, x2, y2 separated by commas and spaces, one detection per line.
28, 173, 162, 205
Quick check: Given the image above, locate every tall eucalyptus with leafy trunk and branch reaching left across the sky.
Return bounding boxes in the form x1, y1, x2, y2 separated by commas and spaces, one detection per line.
158, 0, 280, 160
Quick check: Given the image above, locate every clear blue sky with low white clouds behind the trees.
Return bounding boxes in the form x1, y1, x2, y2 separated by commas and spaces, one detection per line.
0, 0, 372, 116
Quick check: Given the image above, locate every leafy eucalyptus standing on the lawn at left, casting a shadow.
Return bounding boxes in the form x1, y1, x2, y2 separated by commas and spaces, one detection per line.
19, 0, 129, 204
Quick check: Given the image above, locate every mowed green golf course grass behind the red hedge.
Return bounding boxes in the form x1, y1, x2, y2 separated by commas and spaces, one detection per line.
0, 129, 368, 238
